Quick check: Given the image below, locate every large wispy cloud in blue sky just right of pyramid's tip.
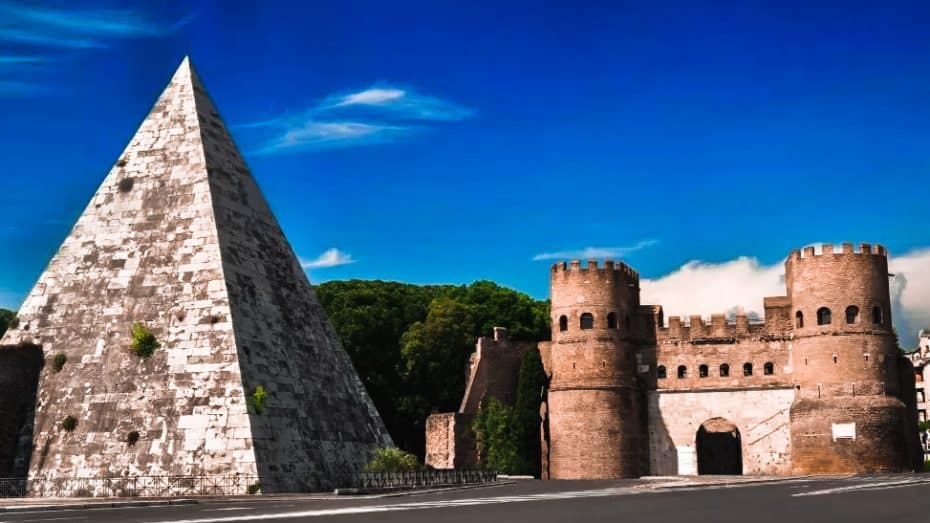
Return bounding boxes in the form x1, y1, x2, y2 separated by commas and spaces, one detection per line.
236, 87, 474, 154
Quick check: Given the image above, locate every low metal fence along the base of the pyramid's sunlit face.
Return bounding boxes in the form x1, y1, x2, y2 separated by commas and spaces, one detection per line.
0, 475, 259, 498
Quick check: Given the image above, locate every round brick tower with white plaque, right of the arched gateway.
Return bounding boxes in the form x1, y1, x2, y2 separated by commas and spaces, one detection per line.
785, 244, 913, 474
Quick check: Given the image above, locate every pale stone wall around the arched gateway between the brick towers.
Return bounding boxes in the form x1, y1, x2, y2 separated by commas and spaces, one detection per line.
648, 386, 794, 476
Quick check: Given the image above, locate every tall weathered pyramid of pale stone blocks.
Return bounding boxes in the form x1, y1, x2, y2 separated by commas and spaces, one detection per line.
0, 58, 391, 492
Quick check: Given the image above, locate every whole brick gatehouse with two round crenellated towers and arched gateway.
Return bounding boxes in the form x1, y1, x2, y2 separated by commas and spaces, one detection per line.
428, 244, 922, 479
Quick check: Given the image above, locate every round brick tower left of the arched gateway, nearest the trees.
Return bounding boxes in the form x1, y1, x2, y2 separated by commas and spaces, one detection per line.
548, 260, 641, 479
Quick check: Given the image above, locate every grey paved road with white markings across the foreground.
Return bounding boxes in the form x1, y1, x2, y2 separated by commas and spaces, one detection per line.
0, 475, 930, 523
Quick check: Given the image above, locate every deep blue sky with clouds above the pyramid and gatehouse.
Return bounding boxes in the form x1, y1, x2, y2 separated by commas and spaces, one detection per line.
0, 0, 930, 344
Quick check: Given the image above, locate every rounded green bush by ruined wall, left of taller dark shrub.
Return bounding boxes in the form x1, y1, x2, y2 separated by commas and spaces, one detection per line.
472, 397, 522, 474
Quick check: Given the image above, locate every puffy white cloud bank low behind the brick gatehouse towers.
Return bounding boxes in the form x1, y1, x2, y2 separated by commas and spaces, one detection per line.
640, 249, 930, 348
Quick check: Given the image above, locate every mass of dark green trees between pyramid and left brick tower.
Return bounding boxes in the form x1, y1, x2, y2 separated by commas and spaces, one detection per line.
316, 280, 550, 456
